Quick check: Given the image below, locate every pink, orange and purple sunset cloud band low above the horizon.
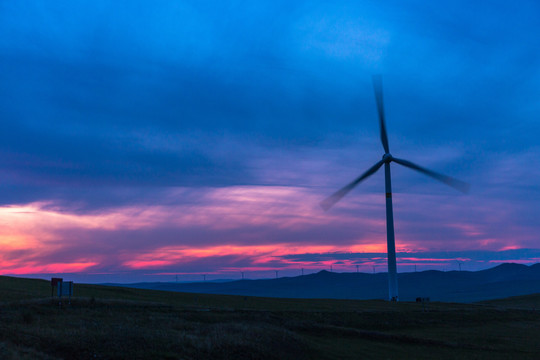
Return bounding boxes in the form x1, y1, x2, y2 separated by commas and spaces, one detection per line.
0, 186, 531, 280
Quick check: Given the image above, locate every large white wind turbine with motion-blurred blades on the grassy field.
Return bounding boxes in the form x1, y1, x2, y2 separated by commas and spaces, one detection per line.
321, 75, 469, 301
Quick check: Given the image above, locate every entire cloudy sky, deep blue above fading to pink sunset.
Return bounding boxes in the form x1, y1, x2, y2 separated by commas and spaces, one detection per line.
0, 0, 540, 282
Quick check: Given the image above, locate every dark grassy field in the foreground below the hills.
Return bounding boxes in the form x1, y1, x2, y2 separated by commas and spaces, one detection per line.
0, 277, 540, 359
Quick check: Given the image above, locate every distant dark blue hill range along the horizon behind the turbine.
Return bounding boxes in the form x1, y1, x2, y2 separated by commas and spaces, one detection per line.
107, 263, 540, 302
